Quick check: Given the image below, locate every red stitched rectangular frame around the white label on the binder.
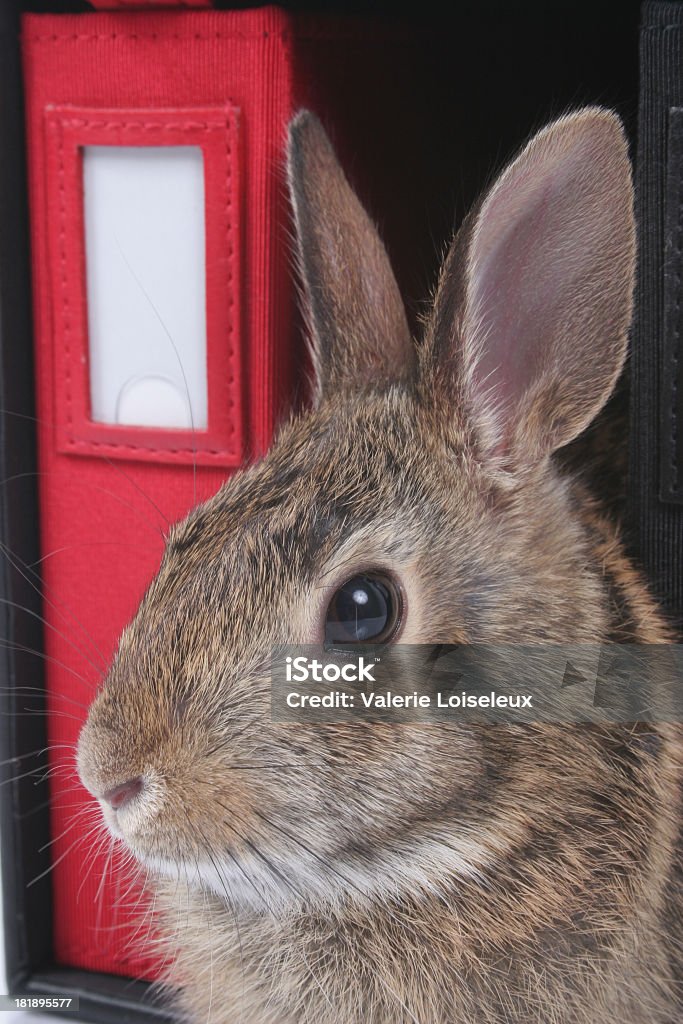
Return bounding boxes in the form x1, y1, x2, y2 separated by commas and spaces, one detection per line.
45, 105, 244, 467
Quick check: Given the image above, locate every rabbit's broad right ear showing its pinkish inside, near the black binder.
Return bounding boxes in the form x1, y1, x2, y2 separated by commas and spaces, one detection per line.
425, 108, 635, 468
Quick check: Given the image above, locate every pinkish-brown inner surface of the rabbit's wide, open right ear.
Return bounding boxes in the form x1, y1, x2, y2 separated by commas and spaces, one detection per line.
465, 121, 631, 456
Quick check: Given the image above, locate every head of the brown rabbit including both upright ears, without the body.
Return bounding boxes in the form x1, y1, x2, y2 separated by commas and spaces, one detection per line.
79, 109, 635, 905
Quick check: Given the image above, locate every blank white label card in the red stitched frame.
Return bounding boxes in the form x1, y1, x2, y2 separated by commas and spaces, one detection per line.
83, 145, 207, 430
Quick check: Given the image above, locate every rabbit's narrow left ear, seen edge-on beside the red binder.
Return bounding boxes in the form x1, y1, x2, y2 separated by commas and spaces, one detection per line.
288, 111, 415, 400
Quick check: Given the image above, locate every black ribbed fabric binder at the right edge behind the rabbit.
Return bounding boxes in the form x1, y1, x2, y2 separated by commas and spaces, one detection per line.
628, 2, 683, 626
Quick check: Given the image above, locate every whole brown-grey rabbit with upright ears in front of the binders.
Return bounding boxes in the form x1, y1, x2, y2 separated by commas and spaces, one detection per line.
78, 108, 683, 1024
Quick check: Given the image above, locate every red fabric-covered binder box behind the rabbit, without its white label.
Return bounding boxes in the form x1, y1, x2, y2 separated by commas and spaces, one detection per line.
24, 7, 447, 977
